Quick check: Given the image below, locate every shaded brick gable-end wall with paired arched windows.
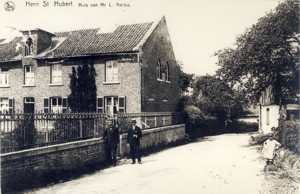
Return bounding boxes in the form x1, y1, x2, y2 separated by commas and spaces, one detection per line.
141, 16, 180, 112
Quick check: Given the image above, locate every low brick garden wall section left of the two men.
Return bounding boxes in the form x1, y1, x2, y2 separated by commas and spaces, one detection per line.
1, 139, 105, 191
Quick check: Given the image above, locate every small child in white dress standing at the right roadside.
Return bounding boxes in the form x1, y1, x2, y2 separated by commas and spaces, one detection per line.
262, 136, 281, 166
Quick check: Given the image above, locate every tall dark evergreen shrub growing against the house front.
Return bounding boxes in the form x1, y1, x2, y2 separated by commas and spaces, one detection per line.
69, 61, 97, 112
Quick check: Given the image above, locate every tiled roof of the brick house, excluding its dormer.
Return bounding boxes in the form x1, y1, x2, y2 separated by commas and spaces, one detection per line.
0, 22, 154, 61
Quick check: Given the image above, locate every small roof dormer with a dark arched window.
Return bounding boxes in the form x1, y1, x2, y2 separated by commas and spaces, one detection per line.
20, 28, 55, 56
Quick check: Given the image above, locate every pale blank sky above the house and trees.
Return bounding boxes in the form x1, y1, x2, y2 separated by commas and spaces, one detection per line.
0, 0, 280, 75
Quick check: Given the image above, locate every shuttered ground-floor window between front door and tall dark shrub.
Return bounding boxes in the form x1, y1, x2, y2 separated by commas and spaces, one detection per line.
44, 97, 68, 113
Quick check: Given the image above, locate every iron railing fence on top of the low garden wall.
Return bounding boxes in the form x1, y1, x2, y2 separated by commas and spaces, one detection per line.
0, 112, 183, 153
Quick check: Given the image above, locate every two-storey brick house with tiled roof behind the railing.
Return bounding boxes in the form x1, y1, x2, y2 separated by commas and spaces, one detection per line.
0, 17, 180, 113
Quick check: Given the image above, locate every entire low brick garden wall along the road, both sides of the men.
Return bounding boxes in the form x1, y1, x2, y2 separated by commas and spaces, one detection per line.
1, 125, 185, 192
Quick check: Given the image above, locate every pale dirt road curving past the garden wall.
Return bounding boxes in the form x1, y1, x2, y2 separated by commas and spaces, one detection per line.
27, 134, 298, 194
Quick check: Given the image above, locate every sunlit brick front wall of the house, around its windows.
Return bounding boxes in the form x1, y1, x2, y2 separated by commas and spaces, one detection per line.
0, 56, 141, 112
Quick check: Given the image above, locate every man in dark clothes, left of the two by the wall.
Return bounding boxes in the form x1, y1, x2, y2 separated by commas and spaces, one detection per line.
103, 119, 120, 166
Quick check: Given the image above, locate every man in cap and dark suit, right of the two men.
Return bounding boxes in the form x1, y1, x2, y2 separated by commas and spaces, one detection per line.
127, 119, 142, 164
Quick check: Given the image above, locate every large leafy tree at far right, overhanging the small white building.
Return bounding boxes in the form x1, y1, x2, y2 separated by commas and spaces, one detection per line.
216, 1, 299, 104
